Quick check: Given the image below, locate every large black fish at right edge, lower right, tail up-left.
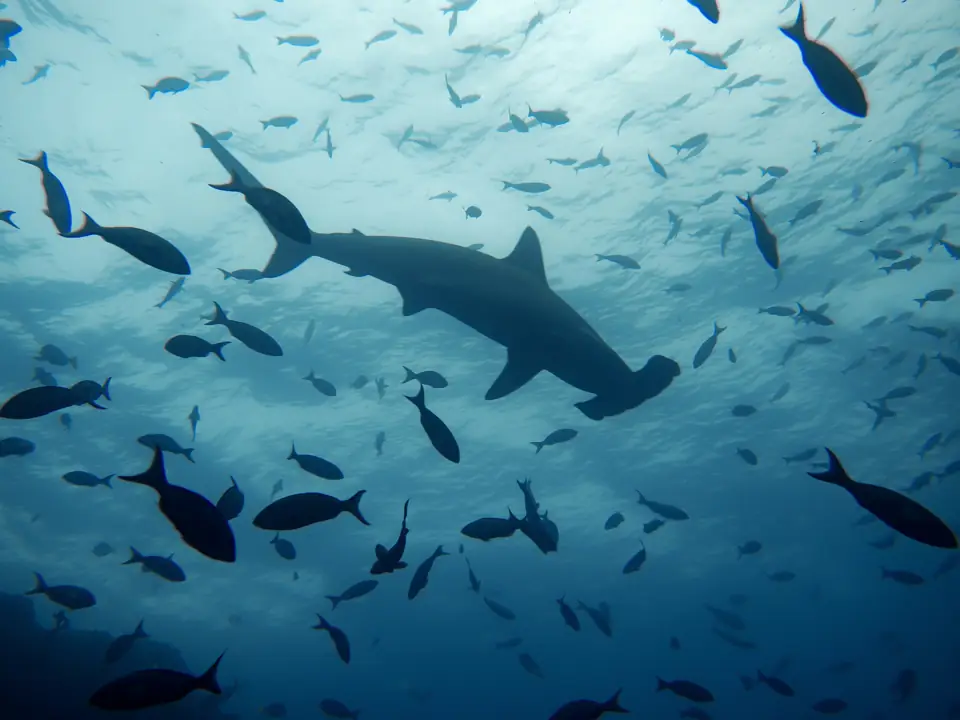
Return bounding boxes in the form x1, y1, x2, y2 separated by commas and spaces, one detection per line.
807, 448, 957, 549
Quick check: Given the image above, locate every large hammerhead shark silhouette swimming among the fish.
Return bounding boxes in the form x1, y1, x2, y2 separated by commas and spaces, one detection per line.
193, 124, 680, 420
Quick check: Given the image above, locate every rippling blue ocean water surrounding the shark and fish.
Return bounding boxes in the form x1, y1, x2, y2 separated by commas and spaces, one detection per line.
0, 0, 960, 720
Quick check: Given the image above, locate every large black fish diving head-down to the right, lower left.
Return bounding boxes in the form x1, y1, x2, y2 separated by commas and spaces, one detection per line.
119, 447, 237, 563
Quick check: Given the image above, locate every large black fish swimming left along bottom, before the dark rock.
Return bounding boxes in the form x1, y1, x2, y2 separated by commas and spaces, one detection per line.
88, 654, 223, 710
